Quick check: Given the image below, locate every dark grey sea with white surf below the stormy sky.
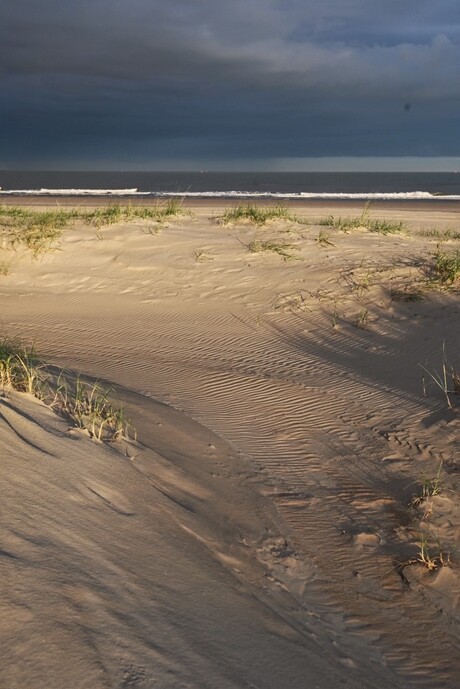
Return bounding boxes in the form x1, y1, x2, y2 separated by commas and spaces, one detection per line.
0, 170, 460, 201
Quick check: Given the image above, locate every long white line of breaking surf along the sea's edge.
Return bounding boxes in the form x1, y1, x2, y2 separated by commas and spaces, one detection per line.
0, 188, 460, 201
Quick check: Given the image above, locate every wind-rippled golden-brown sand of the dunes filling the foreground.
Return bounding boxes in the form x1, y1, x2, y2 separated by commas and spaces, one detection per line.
0, 199, 460, 689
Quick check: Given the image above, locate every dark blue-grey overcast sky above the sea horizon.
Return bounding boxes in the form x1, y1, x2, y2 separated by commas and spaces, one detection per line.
0, 0, 460, 170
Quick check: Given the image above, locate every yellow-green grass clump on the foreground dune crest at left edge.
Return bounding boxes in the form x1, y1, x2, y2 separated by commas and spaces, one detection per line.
0, 338, 135, 442
